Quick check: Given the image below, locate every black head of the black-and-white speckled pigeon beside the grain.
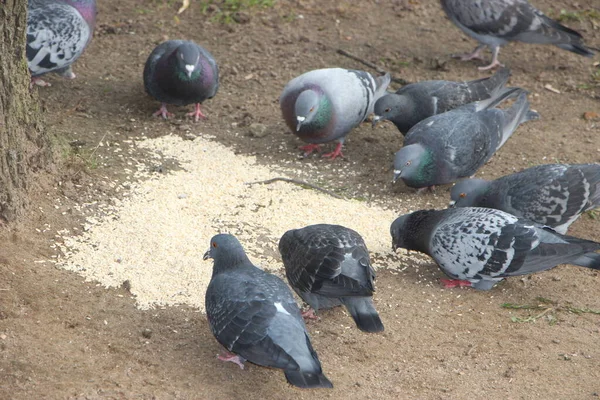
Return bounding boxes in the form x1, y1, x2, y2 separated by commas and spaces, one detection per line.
390, 210, 435, 252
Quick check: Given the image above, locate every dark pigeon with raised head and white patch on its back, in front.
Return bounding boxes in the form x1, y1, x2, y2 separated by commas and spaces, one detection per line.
204, 234, 333, 388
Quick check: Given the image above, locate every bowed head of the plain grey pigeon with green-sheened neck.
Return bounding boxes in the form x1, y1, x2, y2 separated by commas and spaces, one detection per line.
393, 143, 435, 186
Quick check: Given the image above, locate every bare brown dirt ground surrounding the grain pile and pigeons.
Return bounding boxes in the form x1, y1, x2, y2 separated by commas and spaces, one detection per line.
0, 0, 600, 399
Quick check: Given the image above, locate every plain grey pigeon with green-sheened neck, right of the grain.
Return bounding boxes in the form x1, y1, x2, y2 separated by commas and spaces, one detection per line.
394, 89, 538, 188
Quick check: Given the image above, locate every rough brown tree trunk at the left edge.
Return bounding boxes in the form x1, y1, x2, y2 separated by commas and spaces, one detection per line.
0, 0, 52, 223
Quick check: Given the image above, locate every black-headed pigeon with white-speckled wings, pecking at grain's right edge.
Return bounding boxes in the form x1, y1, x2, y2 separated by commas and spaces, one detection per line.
391, 207, 600, 290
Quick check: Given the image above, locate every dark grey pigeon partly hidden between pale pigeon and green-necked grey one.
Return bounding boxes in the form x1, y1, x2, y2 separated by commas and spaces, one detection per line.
373, 68, 517, 135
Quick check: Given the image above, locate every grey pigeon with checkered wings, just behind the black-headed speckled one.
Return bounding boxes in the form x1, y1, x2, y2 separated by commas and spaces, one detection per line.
450, 164, 600, 235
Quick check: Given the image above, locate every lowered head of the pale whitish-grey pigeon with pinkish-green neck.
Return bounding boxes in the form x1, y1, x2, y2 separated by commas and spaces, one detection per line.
294, 89, 331, 132
